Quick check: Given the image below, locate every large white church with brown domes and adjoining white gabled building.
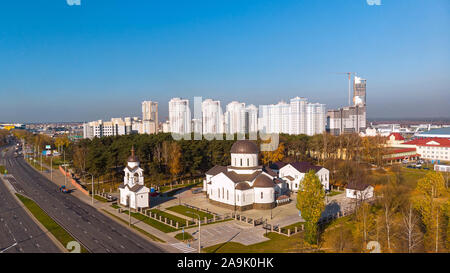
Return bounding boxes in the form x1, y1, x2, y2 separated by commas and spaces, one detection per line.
203, 140, 330, 211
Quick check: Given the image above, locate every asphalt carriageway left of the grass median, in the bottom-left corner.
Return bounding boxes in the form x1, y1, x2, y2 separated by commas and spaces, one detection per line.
0, 173, 61, 253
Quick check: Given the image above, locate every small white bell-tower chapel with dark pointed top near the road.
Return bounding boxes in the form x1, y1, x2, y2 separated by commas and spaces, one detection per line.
119, 147, 150, 209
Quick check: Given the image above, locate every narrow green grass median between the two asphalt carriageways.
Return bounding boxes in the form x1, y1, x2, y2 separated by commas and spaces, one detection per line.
16, 193, 88, 253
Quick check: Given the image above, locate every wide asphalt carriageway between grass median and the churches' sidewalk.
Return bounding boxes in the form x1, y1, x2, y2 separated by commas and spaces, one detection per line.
4, 143, 166, 253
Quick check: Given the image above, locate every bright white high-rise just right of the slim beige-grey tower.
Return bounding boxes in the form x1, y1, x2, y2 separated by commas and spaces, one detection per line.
169, 98, 192, 134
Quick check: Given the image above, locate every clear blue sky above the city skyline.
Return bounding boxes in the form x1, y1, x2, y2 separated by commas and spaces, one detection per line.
0, 0, 450, 122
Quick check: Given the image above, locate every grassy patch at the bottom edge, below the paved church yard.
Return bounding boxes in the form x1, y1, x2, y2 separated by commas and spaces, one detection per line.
203, 232, 305, 253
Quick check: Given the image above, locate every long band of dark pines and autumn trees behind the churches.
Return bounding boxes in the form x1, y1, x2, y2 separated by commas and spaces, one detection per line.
14, 130, 385, 187
